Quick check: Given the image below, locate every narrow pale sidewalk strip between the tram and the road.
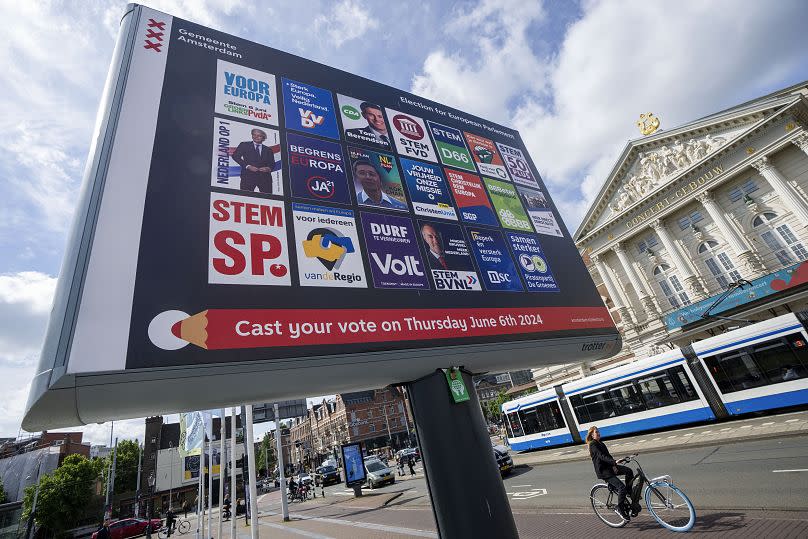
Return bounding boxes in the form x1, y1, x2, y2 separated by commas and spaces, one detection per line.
512, 411, 808, 466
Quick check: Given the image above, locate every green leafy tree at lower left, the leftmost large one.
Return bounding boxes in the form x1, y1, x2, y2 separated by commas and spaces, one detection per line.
22, 455, 100, 534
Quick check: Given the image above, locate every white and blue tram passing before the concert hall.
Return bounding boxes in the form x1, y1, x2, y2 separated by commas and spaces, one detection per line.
502, 313, 808, 451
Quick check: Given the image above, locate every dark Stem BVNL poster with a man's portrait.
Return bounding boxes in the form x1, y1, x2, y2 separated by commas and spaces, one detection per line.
418, 221, 482, 290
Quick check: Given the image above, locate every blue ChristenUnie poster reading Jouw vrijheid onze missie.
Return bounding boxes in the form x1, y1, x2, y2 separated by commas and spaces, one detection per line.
401, 157, 457, 221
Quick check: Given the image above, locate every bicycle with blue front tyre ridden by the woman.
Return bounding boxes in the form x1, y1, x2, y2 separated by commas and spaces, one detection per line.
589, 453, 696, 532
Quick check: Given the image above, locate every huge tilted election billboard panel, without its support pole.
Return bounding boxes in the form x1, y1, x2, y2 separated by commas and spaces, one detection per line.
24, 5, 620, 430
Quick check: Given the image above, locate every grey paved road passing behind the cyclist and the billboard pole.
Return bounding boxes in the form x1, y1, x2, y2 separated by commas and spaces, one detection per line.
242, 436, 808, 539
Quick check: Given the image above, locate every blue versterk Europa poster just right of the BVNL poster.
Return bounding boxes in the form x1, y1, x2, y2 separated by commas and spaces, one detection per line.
469, 228, 524, 292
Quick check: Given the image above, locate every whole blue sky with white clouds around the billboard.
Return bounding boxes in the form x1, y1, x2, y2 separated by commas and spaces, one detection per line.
0, 0, 808, 443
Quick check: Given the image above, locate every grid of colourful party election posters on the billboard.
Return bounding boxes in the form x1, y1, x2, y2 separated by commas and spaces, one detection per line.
208, 60, 563, 292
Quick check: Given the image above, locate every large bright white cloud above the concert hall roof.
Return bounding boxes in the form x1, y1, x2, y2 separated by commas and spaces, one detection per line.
412, 0, 808, 230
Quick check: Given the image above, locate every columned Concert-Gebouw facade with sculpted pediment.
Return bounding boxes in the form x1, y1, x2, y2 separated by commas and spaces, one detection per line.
568, 82, 808, 374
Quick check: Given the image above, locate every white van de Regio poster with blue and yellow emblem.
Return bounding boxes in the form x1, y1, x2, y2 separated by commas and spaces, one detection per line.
292, 203, 367, 288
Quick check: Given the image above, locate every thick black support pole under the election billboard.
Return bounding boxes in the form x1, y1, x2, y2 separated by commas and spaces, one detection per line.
407, 369, 519, 539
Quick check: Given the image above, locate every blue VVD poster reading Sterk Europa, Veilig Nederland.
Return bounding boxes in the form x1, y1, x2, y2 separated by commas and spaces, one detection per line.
281, 79, 339, 140
